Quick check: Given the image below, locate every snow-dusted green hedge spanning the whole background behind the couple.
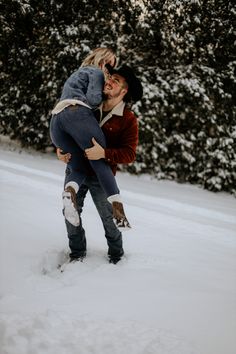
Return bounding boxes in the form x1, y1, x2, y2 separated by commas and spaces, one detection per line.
0, 0, 236, 193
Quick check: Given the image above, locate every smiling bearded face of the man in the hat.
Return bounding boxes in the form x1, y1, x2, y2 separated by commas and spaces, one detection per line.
103, 74, 128, 99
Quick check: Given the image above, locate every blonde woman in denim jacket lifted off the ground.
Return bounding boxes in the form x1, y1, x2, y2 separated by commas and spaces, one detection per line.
50, 48, 130, 228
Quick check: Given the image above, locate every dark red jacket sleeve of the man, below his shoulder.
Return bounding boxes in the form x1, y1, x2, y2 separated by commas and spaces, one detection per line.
105, 114, 138, 164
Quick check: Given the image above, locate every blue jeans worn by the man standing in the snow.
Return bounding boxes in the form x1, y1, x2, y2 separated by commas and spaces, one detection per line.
65, 174, 124, 257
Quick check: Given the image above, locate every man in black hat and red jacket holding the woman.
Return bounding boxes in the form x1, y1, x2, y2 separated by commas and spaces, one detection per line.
57, 65, 143, 264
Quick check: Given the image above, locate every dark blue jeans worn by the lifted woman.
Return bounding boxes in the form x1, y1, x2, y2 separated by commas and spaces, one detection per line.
50, 105, 119, 197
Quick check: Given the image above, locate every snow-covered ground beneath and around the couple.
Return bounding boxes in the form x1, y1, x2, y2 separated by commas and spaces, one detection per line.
0, 147, 236, 354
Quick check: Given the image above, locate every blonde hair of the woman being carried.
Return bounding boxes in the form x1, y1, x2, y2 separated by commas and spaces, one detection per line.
81, 48, 117, 67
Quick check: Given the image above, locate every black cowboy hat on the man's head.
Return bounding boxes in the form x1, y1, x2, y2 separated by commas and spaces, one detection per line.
106, 64, 143, 102
